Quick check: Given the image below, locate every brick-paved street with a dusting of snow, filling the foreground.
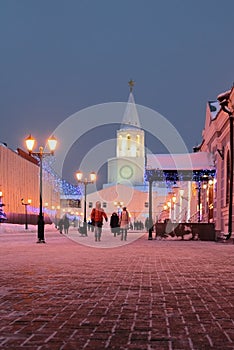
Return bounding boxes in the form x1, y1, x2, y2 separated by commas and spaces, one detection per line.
0, 228, 234, 350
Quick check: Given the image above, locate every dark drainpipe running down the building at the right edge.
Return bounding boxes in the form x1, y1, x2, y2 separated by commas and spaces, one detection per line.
217, 91, 234, 240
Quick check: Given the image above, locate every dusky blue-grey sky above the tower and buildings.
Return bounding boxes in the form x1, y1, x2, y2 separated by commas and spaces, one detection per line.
0, 0, 234, 189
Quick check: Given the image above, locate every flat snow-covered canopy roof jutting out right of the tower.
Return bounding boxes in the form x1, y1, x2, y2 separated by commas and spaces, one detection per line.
146, 152, 214, 170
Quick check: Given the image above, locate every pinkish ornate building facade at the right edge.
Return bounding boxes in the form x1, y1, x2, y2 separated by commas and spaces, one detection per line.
199, 87, 234, 234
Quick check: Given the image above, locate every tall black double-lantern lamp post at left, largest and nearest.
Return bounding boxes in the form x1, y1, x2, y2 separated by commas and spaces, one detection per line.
25, 135, 57, 243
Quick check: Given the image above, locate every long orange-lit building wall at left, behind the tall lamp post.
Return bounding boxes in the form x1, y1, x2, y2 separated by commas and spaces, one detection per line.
0, 144, 60, 224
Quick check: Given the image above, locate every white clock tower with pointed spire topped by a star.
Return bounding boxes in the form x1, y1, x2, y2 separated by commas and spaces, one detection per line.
108, 80, 145, 186
